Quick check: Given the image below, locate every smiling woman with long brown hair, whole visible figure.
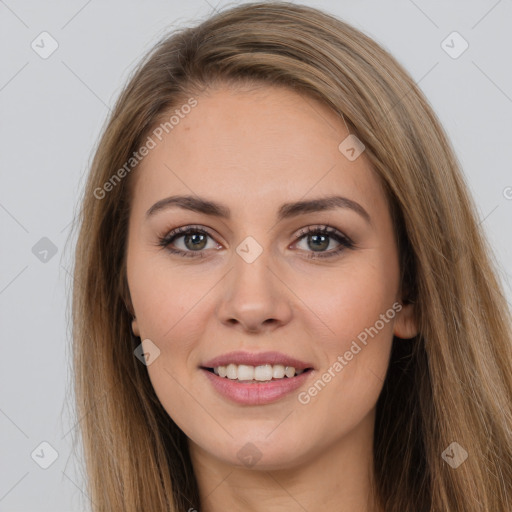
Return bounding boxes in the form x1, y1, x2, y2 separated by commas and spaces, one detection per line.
73, 2, 512, 512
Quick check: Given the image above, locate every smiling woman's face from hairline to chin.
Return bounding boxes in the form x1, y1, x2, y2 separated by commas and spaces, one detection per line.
127, 86, 415, 469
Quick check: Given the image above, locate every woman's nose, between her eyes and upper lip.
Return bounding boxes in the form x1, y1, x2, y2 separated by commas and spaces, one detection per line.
217, 246, 293, 333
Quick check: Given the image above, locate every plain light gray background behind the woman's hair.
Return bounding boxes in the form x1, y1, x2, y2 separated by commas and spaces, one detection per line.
0, 0, 512, 512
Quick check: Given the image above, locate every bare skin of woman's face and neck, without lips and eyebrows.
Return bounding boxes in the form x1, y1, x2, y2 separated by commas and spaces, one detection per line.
127, 86, 417, 512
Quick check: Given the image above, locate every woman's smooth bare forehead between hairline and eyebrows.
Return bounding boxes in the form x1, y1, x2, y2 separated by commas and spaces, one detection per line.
130, 86, 383, 216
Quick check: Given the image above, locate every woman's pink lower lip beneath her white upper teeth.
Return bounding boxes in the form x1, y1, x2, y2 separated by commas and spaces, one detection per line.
201, 368, 313, 405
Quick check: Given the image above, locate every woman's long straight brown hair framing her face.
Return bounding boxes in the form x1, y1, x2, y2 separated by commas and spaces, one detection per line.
73, 2, 512, 512
